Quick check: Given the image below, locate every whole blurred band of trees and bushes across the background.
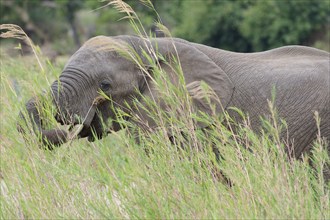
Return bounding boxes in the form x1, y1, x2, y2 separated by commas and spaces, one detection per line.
0, 0, 330, 54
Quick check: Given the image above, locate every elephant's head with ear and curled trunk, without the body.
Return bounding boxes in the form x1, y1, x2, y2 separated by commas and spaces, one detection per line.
18, 36, 233, 144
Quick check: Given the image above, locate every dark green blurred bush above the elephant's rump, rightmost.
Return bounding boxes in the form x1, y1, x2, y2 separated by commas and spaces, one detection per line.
239, 1, 330, 51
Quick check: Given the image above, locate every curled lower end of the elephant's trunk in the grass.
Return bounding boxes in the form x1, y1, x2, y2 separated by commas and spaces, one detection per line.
17, 95, 68, 149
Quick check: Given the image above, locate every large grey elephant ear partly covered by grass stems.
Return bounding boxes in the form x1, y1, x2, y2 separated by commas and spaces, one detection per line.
132, 38, 234, 130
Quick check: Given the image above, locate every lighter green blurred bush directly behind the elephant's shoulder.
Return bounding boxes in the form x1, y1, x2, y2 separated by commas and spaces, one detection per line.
168, 1, 251, 51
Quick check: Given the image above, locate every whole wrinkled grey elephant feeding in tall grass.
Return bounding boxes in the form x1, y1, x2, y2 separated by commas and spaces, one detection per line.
19, 36, 330, 157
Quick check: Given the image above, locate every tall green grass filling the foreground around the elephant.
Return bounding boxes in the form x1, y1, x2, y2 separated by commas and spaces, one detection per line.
0, 1, 330, 219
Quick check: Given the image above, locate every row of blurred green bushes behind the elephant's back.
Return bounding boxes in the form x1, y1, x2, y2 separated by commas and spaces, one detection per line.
172, 0, 330, 52
